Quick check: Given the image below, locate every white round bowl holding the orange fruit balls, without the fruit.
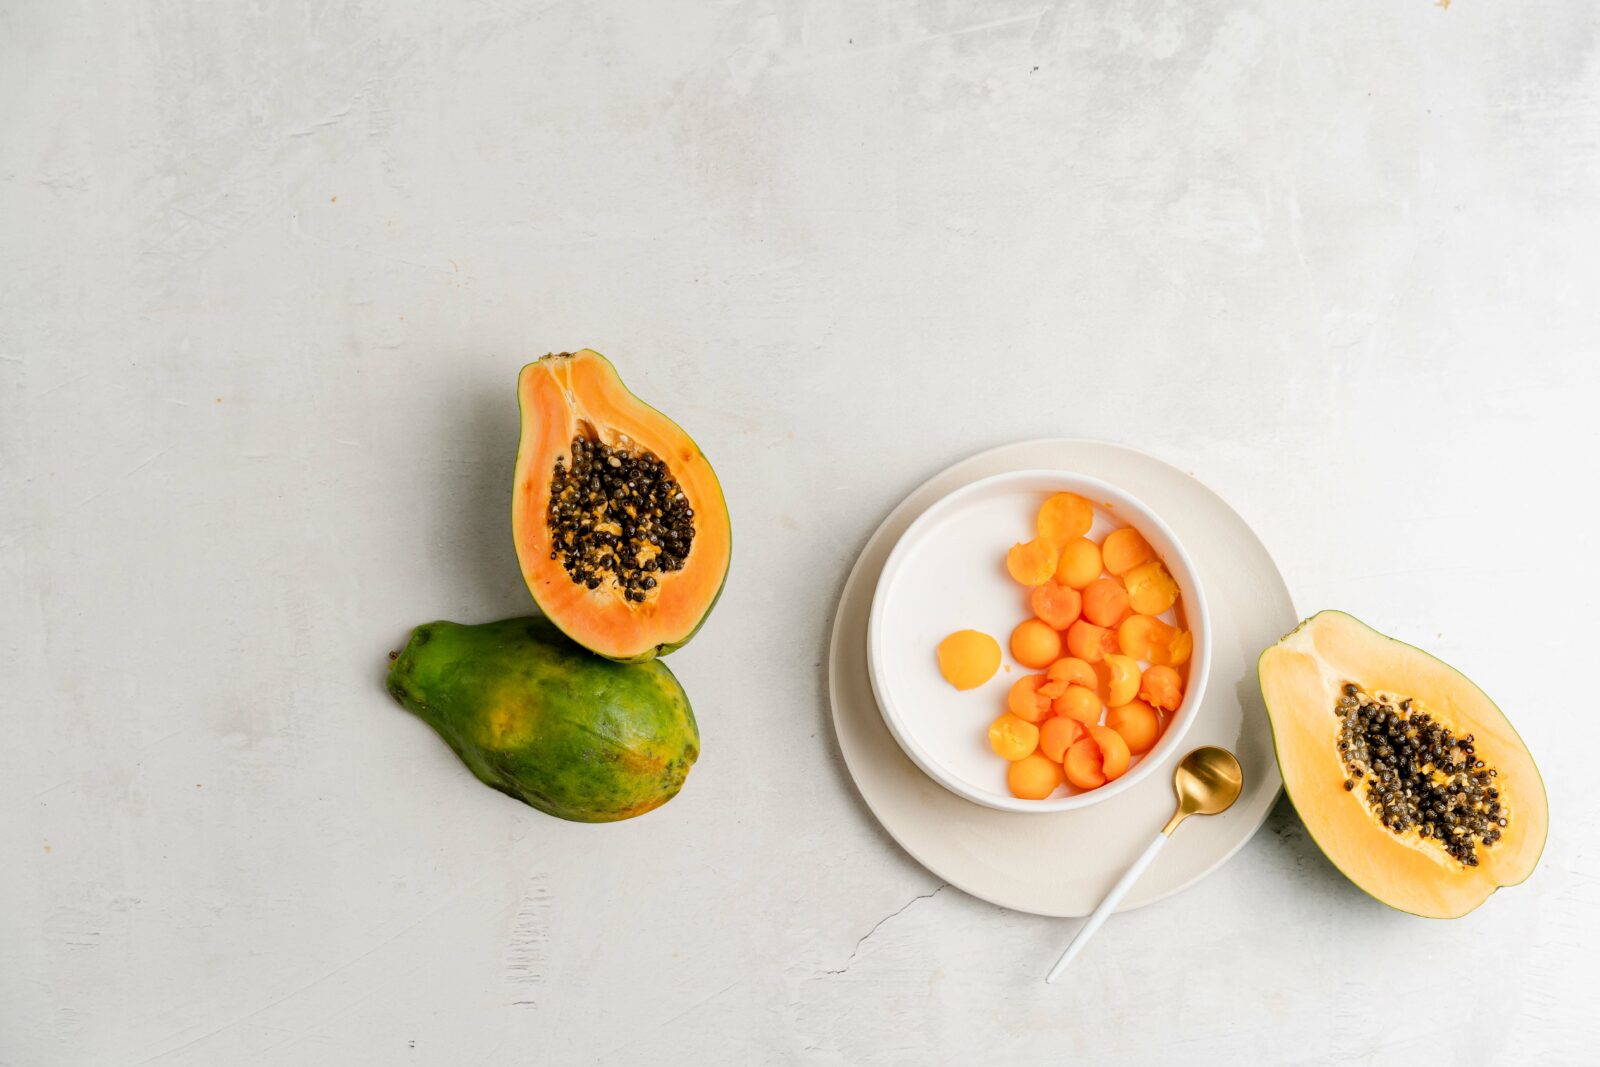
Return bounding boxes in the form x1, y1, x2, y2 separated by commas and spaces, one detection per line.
867, 470, 1211, 813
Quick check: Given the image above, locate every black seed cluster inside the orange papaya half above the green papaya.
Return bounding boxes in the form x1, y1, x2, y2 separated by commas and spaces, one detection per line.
546, 435, 694, 603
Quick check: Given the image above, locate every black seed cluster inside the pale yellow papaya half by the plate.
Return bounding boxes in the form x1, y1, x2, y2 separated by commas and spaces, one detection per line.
1333, 683, 1507, 867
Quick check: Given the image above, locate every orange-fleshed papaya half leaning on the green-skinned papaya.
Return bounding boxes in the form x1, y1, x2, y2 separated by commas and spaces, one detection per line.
510, 349, 733, 662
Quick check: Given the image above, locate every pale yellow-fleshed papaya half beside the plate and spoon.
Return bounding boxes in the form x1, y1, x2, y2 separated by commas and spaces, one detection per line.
1259, 611, 1549, 918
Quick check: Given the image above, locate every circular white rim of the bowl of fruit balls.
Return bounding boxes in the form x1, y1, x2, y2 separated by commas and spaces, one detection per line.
867, 467, 1211, 814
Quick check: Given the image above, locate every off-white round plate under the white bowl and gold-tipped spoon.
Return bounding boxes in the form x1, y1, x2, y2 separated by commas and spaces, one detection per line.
829, 440, 1298, 915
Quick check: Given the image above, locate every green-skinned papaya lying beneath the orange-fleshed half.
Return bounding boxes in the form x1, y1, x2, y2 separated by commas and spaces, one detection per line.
387, 617, 699, 822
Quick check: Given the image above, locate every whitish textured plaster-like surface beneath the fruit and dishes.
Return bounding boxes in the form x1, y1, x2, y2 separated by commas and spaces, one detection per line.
0, 0, 1600, 1067
